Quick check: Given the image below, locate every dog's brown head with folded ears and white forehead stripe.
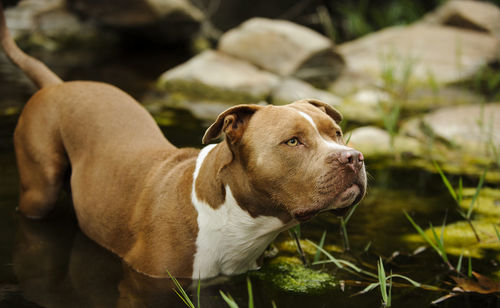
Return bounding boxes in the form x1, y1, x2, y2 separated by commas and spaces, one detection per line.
203, 99, 366, 221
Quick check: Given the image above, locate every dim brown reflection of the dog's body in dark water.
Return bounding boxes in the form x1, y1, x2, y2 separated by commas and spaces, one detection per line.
13, 202, 234, 308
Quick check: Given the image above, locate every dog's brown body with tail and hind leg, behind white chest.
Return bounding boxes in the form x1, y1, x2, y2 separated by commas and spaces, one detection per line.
0, 3, 198, 273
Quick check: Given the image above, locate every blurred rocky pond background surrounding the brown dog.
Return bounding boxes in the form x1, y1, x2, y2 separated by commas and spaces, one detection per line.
0, 0, 500, 308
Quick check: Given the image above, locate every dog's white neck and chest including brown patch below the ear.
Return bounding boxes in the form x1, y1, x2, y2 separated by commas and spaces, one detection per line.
191, 143, 290, 279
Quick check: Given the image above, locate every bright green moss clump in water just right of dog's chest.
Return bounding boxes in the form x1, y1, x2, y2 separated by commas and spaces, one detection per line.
253, 257, 337, 294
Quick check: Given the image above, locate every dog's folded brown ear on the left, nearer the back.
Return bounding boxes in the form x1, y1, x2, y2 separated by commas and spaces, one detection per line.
202, 105, 262, 144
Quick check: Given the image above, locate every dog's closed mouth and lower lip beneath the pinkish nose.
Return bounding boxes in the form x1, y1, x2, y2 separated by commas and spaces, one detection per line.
293, 184, 364, 222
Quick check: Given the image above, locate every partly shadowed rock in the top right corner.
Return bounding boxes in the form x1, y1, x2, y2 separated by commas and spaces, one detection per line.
421, 1, 500, 38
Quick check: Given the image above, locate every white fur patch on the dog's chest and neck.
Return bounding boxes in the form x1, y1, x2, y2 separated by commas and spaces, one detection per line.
191, 145, 285, 279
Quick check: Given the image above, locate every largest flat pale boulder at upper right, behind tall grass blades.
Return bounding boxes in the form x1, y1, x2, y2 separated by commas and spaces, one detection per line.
338, 24, 500, 84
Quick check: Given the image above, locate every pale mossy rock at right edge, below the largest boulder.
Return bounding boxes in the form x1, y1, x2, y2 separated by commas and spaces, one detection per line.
400, 103, 500, 183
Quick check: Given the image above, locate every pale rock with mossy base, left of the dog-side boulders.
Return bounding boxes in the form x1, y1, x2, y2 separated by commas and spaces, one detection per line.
158, 50, 279, 104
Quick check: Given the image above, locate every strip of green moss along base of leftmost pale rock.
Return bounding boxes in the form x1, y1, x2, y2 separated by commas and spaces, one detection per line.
157, 79, 267, 105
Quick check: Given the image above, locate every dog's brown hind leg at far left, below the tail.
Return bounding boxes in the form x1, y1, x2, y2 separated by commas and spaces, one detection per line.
14, 108, 69, 218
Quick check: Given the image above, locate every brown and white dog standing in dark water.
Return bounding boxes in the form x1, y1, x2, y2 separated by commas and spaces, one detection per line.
0, 4, 366, 278
